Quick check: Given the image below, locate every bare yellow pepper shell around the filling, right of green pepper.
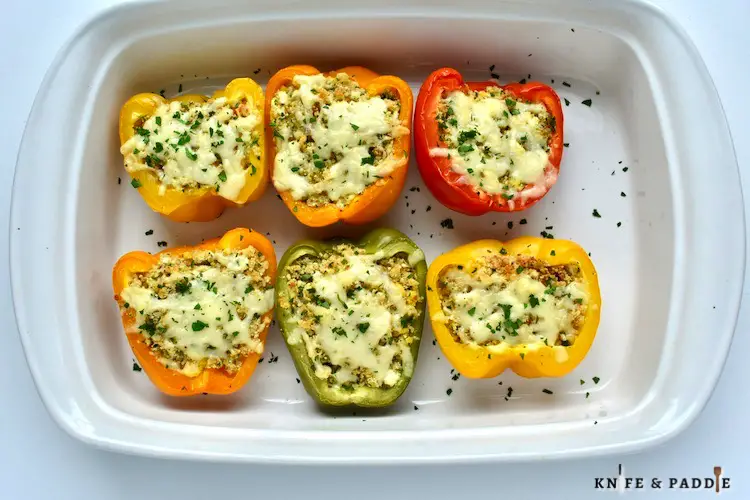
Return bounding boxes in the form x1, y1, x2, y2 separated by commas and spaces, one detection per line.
427, 237, 601, 378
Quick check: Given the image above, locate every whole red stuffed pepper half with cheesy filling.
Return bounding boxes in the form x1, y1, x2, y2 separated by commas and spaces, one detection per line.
414, 68, 563, 215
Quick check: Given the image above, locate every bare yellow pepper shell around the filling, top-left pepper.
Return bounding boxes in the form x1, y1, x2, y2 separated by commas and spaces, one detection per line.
119, 78, 269, 222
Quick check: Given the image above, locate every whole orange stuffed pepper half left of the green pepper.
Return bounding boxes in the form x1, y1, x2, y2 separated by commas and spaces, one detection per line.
112, 229, 276, 396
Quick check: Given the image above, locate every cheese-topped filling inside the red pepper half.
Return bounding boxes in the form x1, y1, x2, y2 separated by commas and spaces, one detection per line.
430, 88, 554, 199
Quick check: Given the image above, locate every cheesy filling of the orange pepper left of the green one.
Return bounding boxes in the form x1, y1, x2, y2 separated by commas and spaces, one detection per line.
120, 250, 274, 377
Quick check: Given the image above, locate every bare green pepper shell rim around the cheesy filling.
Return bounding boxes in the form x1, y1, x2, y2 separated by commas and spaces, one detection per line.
275, 228, 427, 408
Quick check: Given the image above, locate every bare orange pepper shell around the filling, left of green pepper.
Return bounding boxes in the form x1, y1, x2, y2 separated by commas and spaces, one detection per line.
112, 228, 276, 396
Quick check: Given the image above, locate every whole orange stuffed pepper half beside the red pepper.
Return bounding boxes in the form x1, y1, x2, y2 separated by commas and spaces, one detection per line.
266, 66, 413, 227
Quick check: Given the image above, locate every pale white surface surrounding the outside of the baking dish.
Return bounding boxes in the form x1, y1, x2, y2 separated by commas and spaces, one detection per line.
0, 0, 750, 499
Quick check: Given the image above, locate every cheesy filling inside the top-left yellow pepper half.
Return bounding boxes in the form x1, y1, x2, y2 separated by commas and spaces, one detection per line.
120, 97, 262, 200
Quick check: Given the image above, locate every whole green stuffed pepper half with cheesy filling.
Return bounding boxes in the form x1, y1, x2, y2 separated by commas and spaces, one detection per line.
276, 229, 427, 407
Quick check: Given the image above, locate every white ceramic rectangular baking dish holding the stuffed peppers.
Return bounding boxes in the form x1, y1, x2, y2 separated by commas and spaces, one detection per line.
11, 0, 745, 463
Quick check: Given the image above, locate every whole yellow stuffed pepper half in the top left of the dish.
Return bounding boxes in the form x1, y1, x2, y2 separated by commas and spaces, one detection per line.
120, 78, 269, 222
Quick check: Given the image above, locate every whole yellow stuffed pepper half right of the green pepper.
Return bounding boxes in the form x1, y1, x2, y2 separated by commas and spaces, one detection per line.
427, 237, 601, 378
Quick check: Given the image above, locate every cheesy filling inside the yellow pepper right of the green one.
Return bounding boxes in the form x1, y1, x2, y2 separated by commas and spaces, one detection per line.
438, 267, 588, 348
